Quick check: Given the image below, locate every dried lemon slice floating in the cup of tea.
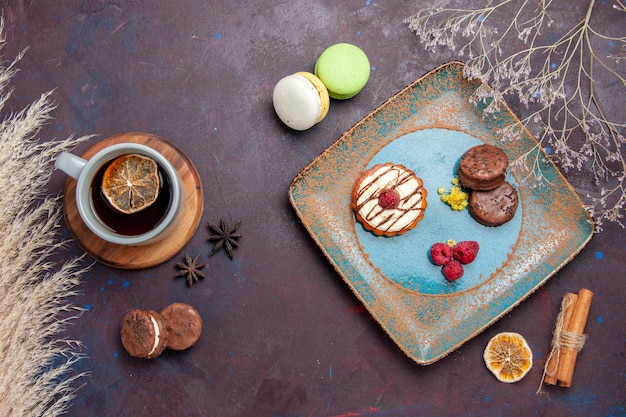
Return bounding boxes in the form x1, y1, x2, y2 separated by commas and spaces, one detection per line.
102, 154, 160, 214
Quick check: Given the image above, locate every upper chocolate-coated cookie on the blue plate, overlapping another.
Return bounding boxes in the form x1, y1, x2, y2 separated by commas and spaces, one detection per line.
457, 144, 509, 190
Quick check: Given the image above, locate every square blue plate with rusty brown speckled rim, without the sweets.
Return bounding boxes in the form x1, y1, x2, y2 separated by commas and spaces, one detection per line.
289, 62, 593, 364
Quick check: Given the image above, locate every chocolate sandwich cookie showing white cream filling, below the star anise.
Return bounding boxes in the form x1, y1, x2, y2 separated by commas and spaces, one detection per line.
120, 309, 167, 359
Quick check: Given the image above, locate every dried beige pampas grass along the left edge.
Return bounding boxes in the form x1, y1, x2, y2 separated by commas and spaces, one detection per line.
0, 21, 92, 417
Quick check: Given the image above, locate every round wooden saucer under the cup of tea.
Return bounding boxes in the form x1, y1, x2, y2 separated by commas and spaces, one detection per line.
63, 132, 204, 269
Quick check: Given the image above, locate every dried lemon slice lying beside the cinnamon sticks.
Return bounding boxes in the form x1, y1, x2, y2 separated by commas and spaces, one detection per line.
483, 332, 533, 383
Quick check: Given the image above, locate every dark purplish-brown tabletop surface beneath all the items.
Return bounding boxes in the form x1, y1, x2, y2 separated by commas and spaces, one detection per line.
2, 0, 626, 417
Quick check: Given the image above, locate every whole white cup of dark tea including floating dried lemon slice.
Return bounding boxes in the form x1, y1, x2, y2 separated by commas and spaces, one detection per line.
55, 143, 182, 246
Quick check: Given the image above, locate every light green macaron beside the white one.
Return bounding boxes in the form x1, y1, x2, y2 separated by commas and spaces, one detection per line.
315, 43, 371, 100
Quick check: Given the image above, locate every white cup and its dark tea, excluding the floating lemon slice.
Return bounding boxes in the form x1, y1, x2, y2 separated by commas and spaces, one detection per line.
55, 143, 183, 246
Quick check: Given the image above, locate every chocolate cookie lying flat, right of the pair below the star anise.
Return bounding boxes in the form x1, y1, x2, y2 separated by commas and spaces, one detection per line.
161, 303, 202, 350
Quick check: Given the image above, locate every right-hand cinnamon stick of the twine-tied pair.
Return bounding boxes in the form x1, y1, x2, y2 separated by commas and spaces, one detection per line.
557, 288, 593, 387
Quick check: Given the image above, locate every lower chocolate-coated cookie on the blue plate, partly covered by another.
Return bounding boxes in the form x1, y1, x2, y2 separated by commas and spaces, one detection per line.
468, 181, 518, 226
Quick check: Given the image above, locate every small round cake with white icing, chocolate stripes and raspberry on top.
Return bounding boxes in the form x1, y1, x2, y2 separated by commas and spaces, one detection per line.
352, 163, 427, 236
